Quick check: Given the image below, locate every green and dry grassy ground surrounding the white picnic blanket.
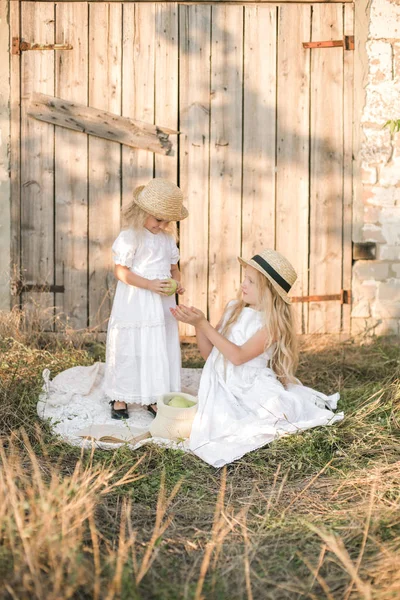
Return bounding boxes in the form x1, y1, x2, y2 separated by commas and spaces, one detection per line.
0, 324, 400, 600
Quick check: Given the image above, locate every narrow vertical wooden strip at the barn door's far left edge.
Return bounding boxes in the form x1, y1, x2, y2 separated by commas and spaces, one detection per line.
9, 2, 21, 306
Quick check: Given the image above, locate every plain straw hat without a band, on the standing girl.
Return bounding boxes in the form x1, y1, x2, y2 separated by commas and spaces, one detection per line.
133, 177, 189, 221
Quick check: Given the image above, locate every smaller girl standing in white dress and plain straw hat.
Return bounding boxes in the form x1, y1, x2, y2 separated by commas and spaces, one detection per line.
104, 178, 188, 419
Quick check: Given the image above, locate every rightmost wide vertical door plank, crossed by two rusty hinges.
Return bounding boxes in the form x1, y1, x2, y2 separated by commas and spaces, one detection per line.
309, 5, 343, 333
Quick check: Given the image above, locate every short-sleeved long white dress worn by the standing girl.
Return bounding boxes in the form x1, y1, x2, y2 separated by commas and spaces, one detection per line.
104, 229, 181, 405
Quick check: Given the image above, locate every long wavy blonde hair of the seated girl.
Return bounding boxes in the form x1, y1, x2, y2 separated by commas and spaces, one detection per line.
220, 270, 298, 385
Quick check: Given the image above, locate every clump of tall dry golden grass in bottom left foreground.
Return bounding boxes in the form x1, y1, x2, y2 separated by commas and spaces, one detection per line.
0, 431, 156, 600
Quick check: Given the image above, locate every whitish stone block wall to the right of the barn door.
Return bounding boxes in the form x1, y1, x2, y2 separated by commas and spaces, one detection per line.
352, 0, 400, 335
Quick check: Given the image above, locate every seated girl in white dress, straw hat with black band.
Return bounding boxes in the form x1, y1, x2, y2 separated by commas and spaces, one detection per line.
171, 249, 343, 467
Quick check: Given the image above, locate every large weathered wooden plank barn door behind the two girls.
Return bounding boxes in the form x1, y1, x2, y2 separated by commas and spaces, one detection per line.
10, 2, 354, 335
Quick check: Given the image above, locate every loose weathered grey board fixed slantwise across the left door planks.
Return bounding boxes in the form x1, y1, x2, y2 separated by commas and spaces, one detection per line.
28, 92, 176, 155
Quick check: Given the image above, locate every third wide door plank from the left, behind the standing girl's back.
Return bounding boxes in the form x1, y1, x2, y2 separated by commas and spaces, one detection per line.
89, 4, 122, 330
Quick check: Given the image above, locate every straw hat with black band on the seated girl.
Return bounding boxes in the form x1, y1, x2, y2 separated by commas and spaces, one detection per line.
238, 248, 297, 304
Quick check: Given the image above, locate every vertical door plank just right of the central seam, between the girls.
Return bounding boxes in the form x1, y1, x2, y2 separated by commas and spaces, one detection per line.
179, 6, 211, 336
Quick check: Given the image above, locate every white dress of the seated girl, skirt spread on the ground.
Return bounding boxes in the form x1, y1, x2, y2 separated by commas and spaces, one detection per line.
189, 302, 343, 467
